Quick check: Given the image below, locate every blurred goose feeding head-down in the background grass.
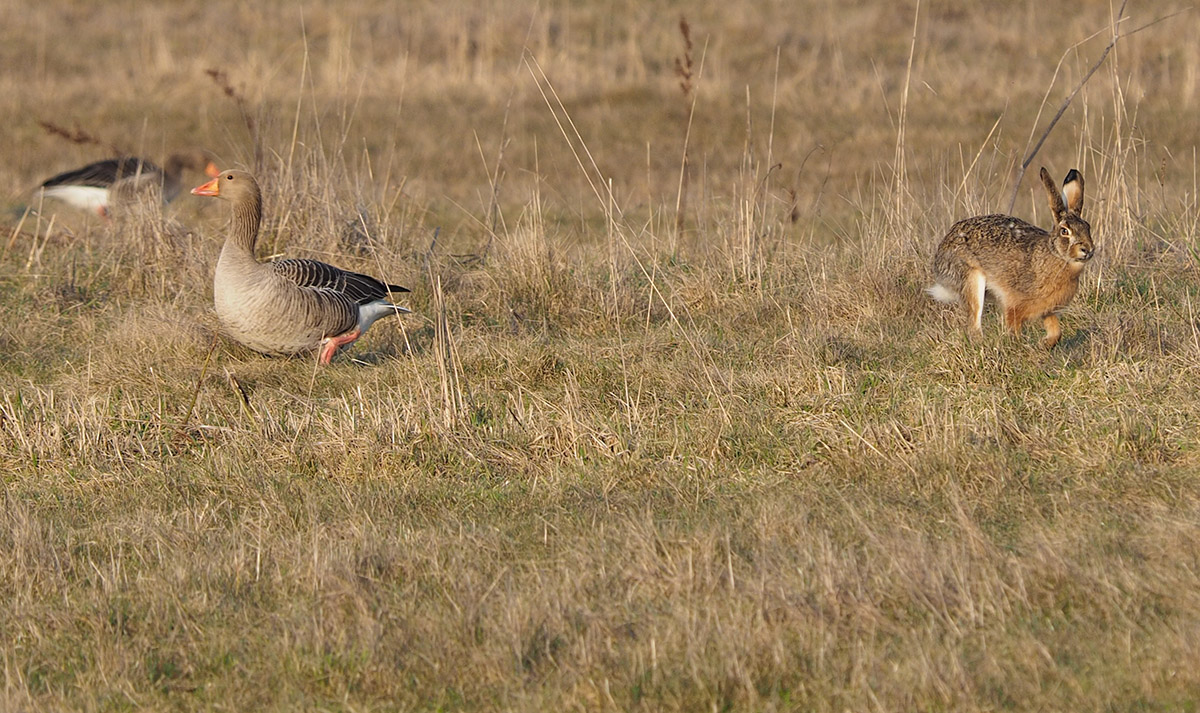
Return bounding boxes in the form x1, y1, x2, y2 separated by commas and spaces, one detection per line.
40, 149, 217, 217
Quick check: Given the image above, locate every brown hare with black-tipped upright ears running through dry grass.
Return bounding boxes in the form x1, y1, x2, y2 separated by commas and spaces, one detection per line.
925, 168, 1096, 348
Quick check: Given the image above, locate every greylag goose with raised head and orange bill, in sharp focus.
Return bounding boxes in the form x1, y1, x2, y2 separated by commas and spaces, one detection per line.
192, 170, 409, 364
